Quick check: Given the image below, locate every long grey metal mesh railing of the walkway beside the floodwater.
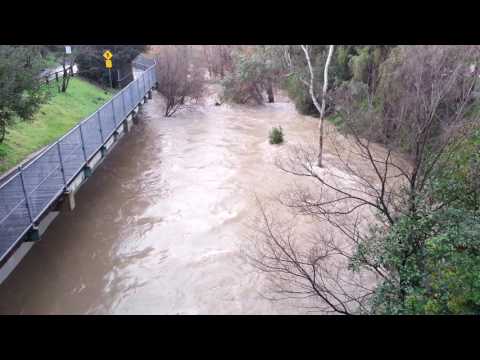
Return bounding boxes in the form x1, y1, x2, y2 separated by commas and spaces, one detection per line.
0, 64, 156, 263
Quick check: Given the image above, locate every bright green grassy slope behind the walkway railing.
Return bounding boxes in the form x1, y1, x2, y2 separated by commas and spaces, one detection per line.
0, 78, 113, 174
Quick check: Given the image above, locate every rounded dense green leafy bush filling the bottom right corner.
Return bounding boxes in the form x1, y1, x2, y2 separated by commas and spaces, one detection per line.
372, 207, 480, 314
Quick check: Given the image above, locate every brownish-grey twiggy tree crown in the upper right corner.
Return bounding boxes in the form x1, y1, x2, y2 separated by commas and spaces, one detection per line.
334, 46, 478, 157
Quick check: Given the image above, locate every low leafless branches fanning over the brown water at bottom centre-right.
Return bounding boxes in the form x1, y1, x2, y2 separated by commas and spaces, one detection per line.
244, 193, 373, 315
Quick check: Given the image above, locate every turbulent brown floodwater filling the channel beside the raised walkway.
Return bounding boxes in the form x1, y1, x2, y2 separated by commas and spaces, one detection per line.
0, 88, 338, 314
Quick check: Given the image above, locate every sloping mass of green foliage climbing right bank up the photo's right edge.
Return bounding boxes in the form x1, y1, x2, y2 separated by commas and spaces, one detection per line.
350, 130, 480, 314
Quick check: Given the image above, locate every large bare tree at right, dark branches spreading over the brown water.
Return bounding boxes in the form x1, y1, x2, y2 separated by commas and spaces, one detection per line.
249, 46, 479, 314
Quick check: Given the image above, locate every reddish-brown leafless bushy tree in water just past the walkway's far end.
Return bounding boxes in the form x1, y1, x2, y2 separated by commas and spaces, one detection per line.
155, 46, 205, 117
